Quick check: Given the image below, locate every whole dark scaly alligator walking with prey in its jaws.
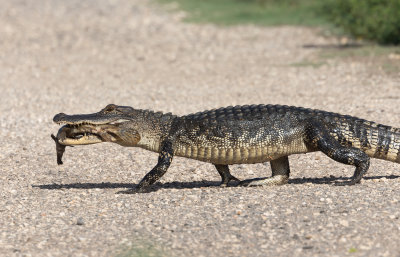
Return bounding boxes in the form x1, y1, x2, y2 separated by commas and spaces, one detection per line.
52, 104, 400, 193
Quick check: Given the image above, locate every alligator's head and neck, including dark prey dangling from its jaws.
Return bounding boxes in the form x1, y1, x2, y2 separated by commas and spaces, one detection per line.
51, 104, 176, 164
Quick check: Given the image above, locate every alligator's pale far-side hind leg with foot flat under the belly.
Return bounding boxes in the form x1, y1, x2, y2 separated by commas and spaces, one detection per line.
240, 156, 290, 186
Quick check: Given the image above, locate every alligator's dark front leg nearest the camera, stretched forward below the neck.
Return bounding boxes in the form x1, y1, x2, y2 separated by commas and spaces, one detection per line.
121, 141, 174, 194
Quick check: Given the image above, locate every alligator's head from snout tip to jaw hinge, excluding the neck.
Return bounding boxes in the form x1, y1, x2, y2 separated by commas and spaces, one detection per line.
53, 104, 140, 146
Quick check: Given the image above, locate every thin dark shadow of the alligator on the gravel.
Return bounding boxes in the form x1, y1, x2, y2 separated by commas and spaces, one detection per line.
32, 175, 400, 192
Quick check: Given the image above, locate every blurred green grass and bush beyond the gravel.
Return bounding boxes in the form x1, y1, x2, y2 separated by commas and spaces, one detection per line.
159, 0, 400, 45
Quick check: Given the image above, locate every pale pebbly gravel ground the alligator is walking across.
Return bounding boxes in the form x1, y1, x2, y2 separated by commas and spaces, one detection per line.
0, 0, 400, 256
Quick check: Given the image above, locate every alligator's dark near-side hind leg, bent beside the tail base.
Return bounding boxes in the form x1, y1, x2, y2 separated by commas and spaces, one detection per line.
306, 121, 369, 186
